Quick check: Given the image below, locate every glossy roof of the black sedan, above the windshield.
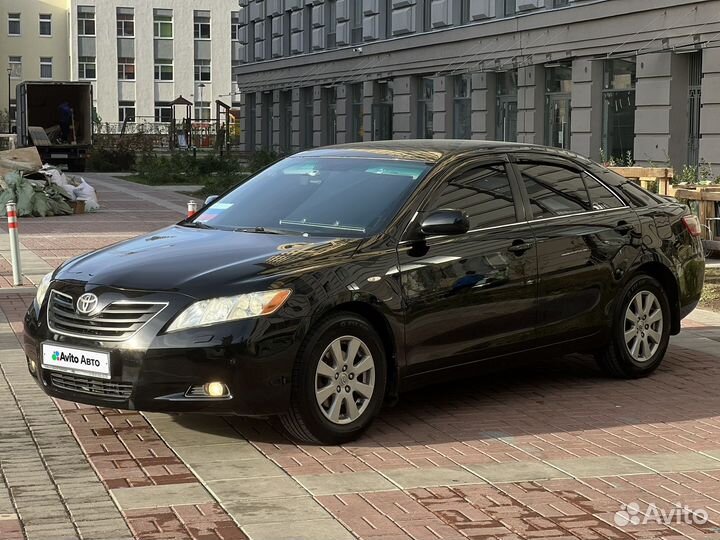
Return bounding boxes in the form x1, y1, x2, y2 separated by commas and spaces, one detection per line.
295, 139, 587, 163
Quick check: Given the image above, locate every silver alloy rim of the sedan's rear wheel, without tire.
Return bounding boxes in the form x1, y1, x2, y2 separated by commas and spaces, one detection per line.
624, 291, 663, 362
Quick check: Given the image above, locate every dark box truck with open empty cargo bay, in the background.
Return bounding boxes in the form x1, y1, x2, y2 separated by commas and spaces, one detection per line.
16, 81, 93, 171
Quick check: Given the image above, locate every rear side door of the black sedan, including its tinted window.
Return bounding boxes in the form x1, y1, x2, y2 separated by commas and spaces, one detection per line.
514, 154, 640, 345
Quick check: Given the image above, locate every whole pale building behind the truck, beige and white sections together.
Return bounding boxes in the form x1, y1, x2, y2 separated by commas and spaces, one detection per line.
0, 0, 238, 130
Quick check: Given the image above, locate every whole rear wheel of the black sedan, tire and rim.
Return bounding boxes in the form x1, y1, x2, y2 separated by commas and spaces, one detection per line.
596, 274, 672, 379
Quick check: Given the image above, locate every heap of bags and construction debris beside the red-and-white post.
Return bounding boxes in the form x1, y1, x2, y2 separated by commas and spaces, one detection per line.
0, 147, 100, 217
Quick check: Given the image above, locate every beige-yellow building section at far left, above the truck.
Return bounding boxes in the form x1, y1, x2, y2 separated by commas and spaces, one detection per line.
0, 0, 70, 131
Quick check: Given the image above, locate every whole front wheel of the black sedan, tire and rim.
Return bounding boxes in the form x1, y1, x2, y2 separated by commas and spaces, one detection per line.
280, 312, 387, 445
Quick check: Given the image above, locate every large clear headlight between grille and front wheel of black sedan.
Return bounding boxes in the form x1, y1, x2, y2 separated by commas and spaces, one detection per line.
168, 289, 292, 332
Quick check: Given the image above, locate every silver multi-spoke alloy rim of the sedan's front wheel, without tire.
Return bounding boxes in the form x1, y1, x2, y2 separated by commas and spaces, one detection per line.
315, 336, 375, 425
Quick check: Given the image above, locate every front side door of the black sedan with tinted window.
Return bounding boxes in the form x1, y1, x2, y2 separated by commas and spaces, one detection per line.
398, 161, 537, 374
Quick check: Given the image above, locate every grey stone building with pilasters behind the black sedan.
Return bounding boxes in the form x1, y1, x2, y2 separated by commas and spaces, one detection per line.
232, 0, 720, 174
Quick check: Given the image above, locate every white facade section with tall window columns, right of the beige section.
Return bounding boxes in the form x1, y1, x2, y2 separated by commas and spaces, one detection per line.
68, 0, 238, 123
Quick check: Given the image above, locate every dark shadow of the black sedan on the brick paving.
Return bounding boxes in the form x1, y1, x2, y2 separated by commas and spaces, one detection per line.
166, 327, 720, 449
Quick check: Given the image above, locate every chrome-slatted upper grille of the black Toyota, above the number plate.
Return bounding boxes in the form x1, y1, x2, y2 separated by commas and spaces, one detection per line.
48, 291, 167, 341
